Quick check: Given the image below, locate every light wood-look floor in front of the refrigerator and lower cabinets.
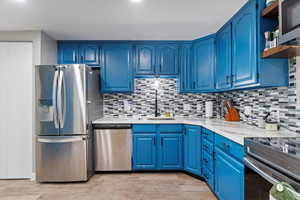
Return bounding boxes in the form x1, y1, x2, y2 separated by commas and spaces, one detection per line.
0, 173, 216, 200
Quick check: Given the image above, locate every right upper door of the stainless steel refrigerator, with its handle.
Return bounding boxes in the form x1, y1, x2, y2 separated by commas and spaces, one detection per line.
57, 64, 87, 135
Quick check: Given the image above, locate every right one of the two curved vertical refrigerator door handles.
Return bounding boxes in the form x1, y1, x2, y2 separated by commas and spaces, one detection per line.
57, 71, 66, 128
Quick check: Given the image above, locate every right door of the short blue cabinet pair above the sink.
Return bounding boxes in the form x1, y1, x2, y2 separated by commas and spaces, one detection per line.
155, 45, 178, 75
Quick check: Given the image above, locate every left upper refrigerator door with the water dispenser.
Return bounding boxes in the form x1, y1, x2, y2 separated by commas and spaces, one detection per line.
35, 65, 59, 135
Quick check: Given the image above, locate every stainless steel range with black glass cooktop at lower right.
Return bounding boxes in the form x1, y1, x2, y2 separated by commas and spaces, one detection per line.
244, 137, 300, 200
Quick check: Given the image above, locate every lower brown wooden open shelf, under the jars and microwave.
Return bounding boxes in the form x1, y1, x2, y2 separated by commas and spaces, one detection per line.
262, 45, 300, 58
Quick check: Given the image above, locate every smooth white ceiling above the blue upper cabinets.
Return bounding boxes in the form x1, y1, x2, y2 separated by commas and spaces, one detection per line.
0, 0, 247, 40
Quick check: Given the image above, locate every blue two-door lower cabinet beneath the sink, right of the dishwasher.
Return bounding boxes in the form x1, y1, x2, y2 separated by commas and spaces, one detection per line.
132, 124, 183, 170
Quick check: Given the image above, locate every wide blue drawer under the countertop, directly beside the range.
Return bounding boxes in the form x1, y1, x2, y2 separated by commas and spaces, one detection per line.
215, 134, 244, 161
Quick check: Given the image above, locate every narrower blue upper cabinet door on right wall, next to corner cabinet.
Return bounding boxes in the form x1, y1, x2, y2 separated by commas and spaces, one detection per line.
215, 23, 232, 89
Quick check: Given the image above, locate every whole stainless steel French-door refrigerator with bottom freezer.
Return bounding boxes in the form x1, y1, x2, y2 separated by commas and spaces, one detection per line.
35, 64, 102, 182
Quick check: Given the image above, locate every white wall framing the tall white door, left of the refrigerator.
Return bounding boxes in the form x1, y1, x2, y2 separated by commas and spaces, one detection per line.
0, 31, 57, 176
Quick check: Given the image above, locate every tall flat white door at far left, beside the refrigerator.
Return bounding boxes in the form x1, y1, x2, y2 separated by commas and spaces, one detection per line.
0, 42, 33, 179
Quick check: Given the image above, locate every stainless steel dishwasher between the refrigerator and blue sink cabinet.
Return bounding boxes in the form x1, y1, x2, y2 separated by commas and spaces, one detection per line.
94, 124, 132, 171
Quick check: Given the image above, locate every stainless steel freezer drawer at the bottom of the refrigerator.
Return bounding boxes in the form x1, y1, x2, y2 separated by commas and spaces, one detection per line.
37, 136, 88, 182
